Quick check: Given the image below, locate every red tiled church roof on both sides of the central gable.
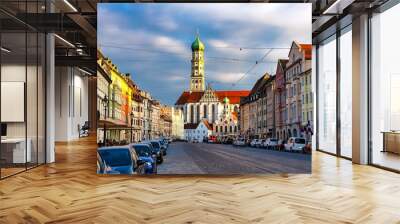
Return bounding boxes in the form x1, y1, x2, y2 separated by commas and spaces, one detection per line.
175, 90, 250, 105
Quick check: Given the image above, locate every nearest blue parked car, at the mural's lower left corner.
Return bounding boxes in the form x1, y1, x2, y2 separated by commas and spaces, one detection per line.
97, 146, 145, 174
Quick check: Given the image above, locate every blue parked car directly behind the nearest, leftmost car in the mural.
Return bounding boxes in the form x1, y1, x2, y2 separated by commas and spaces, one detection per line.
129, 143, 157, 174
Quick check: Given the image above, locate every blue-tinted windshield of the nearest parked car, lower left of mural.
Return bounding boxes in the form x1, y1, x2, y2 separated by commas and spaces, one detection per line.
99, 149, 132, 167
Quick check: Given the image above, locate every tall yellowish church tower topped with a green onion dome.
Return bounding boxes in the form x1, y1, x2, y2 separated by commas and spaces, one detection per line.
190, 34, 205, 92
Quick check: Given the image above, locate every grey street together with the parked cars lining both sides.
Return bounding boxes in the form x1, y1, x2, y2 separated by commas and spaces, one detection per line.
97, 135, 311, 175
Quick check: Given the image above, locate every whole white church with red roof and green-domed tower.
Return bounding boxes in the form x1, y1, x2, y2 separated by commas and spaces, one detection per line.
175, 36, 249, 140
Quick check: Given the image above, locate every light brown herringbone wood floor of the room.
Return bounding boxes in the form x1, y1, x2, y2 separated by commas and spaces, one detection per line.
0, 136, 400, 224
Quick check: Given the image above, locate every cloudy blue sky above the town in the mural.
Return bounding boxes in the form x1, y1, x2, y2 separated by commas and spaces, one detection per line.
97, 3, 312, 105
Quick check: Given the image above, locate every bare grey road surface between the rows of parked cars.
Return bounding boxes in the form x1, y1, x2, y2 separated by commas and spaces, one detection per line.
158, 142, 311, 174
